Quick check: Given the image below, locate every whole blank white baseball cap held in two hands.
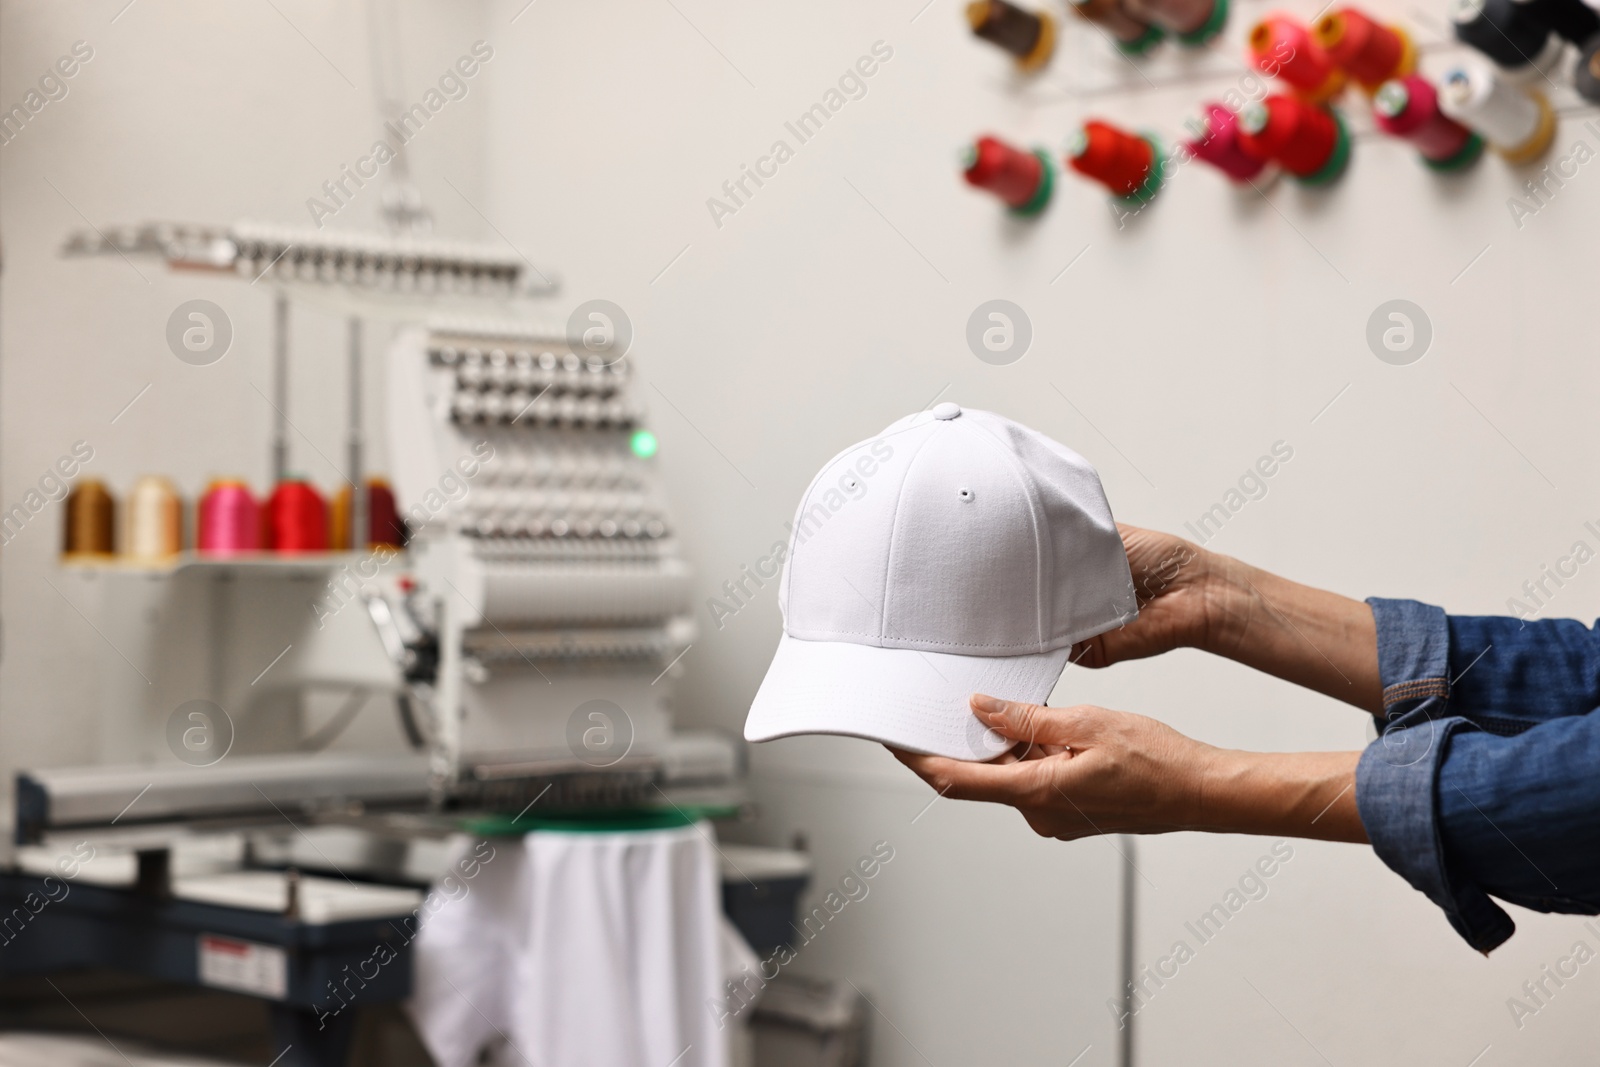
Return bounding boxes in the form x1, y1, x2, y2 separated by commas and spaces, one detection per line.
744, 403, 1138, 760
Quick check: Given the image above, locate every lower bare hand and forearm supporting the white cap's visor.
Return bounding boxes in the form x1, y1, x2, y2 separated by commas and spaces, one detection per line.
891, 696, 1366, 841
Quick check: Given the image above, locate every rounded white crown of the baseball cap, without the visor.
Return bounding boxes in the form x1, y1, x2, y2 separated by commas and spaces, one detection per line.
779, 405, 1138, 656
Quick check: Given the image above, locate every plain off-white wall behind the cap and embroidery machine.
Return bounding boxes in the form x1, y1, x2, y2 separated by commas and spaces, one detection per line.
9, 0, 1600, 1067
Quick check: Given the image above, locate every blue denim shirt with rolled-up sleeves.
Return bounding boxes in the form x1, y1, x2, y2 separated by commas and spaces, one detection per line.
1355, 597, 1600, 953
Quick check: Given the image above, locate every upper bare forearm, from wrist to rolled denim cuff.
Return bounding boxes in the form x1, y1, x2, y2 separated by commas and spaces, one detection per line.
1195, 553, 1382, 715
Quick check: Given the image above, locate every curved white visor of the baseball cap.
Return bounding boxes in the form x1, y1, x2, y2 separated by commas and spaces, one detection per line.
744, 633, 1072, 760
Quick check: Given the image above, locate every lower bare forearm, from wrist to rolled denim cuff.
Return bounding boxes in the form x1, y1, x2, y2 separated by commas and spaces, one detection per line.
1187, 749, 1366, 843
